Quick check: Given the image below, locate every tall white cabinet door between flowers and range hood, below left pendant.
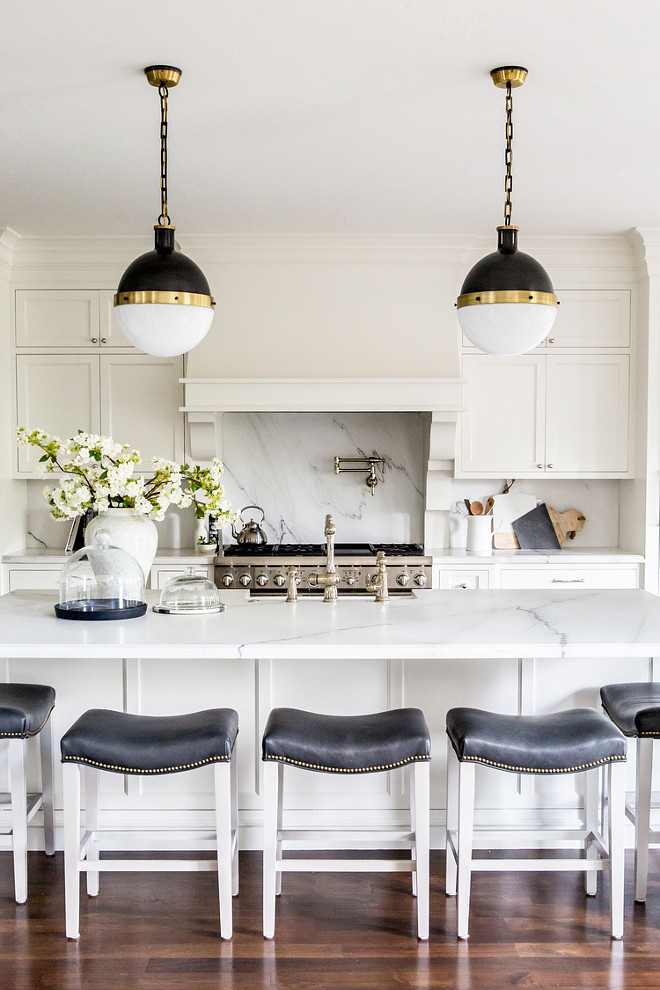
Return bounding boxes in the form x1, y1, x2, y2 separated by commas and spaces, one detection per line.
100, 354, 183, 473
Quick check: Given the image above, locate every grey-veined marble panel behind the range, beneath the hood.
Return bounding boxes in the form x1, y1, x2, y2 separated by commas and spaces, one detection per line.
221, 413, 427, 543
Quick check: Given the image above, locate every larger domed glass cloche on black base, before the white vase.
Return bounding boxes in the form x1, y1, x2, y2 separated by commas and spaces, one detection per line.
55, 530, 147, 620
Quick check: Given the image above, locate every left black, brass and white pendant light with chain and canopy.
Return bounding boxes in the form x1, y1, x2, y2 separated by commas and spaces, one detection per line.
114, 65, 215, 356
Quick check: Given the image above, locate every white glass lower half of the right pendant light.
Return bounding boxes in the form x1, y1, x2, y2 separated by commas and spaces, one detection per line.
458, 303, 557, 355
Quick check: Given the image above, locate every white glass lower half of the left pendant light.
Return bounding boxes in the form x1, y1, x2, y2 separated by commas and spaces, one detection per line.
115, 303, 213, 357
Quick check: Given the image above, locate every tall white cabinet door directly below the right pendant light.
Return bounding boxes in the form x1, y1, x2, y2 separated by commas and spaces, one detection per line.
461, 354, 545, 477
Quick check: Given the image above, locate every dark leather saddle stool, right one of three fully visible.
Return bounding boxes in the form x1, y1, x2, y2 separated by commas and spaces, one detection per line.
446, 708, 626, 938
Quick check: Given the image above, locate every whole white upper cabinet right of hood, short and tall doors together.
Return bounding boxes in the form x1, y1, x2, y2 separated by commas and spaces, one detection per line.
456, 289, 633, 478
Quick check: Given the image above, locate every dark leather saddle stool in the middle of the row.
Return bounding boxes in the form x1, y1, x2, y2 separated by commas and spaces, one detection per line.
262, 708, 431, 939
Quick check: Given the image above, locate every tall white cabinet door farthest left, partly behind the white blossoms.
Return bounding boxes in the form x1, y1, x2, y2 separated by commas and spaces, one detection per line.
16, 354, 100, 474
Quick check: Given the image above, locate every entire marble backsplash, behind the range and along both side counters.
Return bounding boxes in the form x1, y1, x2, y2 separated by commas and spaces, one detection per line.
25, 413, 621, 549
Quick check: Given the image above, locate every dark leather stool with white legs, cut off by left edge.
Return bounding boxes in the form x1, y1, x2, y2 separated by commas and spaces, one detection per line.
0, 684, 55, 904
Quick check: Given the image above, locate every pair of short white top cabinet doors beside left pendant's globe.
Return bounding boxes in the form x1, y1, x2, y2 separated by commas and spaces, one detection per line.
16, 289, 132, 350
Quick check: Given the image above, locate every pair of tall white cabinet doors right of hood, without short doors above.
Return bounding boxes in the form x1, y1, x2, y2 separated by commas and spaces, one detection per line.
457, 353, 631, 478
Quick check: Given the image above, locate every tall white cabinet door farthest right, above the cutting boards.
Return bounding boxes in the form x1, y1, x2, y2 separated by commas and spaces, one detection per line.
546, 354, 629, 475
